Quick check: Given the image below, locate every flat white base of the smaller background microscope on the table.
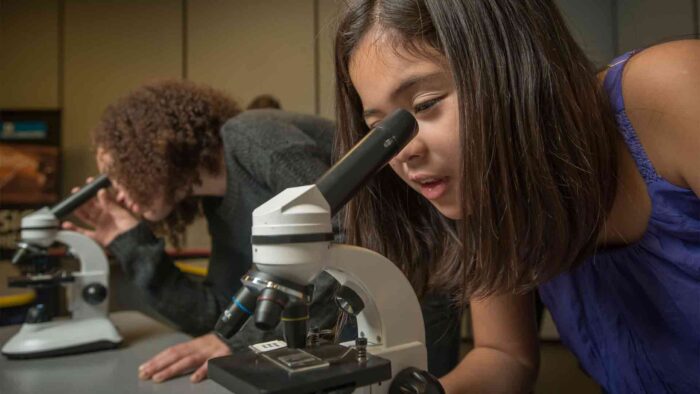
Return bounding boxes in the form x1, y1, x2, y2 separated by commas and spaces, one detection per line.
2, 317, 122, 359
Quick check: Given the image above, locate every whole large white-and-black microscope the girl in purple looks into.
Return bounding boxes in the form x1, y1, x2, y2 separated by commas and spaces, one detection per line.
208, 110, 442, 394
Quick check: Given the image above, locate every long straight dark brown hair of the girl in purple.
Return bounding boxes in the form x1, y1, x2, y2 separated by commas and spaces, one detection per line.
335, 0, 617, 301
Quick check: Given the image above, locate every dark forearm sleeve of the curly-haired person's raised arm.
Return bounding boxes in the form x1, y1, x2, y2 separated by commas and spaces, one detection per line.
107, 222, 229, 335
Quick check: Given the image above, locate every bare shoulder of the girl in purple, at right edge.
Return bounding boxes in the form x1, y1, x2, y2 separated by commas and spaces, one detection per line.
622, 40, 700, 195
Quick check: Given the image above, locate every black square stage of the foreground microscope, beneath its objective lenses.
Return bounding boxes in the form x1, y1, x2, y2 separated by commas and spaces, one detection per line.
208, 344, 391, 394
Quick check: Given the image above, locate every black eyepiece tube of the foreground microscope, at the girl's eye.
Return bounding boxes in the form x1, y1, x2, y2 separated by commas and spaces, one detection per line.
316, 109, 418, 214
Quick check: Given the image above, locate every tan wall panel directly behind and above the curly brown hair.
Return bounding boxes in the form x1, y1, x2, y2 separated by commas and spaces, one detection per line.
63, 0, 182, 192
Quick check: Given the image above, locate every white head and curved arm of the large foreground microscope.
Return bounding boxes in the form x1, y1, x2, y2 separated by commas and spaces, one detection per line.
253, 185, 428, 394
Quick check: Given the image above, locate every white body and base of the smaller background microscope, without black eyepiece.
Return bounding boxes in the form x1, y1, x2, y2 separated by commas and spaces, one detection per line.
2, 178, 122, 358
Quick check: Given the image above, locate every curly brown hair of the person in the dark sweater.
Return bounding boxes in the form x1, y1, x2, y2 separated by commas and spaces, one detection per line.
93, 80, 241, 246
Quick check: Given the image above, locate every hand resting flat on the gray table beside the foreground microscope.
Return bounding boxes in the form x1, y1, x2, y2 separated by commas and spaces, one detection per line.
139, 334, 231, 383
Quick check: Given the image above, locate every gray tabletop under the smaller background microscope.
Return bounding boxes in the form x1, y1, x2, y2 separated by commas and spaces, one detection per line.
0, 311, 228, 394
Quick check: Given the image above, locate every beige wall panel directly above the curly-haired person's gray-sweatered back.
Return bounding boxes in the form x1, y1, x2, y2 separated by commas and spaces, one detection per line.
187, 0, 316, 113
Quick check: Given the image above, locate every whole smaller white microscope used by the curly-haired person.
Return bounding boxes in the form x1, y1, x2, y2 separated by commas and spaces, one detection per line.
2, 175, 122, 359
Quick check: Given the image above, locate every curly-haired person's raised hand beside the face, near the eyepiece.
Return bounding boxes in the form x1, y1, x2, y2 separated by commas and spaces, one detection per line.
62, 178, 139, 246
